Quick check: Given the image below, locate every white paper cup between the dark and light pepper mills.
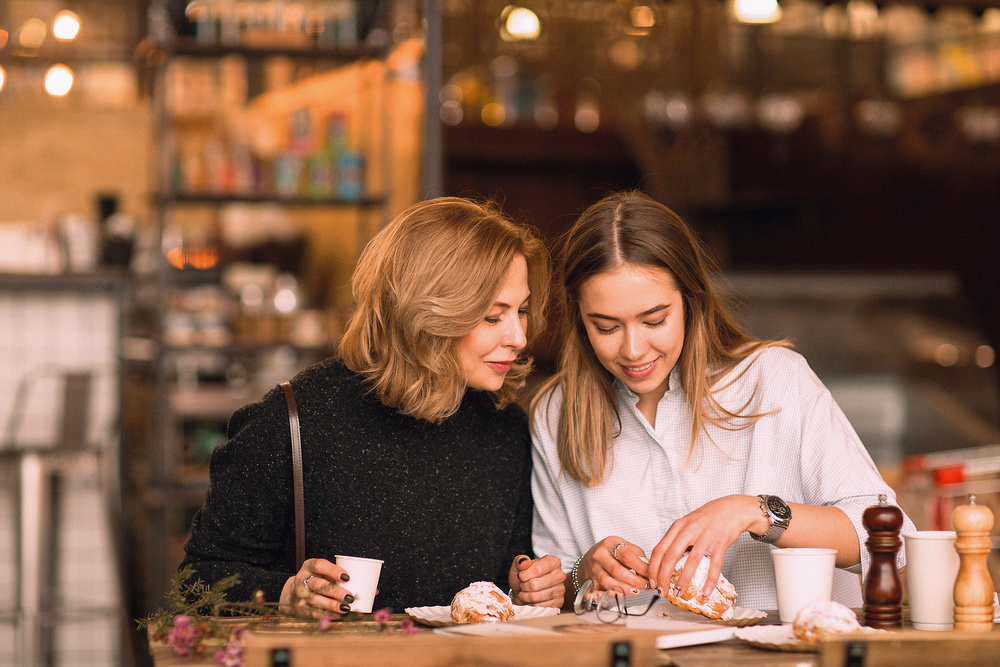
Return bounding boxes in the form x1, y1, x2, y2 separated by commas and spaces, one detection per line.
902, 530, 961, 630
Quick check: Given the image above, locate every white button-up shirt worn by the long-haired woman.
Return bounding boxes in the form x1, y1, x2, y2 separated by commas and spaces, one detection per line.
532, 347, 915, 609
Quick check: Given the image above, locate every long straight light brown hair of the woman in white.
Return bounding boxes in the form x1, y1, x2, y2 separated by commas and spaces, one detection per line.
532, 191, 787, 486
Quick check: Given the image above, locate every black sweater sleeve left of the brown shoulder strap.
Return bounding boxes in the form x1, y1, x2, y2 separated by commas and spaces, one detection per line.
181, 389, 295, 602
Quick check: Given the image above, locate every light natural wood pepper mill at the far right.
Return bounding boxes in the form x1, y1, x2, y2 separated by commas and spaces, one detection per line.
951, 494, 993, 632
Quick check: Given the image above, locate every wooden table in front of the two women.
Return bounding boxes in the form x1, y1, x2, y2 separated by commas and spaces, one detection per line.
150, 612, 1000, 667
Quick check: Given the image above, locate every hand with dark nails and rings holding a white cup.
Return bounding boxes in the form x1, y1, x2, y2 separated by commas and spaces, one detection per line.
278, 558, 354, 619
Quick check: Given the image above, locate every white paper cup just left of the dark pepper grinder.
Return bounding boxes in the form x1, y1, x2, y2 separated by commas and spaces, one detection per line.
771, 548, 837, 623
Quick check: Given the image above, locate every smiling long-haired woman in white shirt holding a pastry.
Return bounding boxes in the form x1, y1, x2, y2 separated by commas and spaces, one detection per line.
532, 192, 913, 609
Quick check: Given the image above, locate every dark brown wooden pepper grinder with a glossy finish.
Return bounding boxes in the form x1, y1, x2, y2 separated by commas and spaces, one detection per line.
861, 493, 903, 630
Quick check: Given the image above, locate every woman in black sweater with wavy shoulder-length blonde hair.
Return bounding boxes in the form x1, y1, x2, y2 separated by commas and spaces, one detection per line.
182, 198, 565, 617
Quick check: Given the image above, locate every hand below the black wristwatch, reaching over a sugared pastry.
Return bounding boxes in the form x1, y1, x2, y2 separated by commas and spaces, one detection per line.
648, 496, 763, 595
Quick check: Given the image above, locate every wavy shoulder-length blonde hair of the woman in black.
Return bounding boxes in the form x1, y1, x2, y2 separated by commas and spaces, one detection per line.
340, 197, 549, 422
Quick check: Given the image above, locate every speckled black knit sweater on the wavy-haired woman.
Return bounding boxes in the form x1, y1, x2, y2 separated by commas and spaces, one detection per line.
182, 359, 532, 612
